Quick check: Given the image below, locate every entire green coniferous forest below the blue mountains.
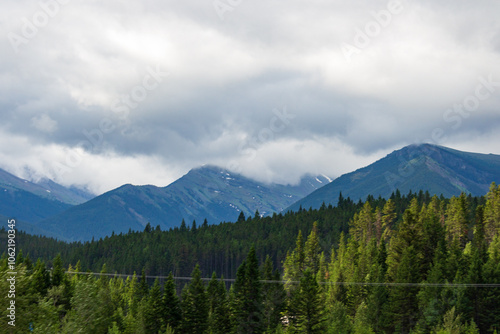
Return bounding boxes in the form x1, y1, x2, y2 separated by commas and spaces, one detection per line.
0, 184, 500, 334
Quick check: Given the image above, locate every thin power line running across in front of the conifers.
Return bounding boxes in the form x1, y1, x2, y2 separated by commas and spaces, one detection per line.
66, 271, 500, 288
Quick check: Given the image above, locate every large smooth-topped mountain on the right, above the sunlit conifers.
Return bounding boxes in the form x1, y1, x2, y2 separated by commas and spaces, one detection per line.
287, 144, 500, 211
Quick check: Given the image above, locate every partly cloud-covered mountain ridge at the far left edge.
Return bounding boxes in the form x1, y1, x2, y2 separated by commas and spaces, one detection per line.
0, 169, 93, 223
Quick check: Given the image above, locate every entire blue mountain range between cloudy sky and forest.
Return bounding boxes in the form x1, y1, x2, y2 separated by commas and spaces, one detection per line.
0, 144, 500, 241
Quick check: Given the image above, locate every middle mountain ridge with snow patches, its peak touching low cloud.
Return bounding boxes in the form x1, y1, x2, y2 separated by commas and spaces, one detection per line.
37, 166, 330, 240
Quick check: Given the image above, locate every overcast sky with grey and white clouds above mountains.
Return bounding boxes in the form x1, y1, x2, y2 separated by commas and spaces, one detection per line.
0, 0, 500, 194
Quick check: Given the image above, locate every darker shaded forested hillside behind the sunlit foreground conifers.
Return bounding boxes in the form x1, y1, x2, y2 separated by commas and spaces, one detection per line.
1, 192, 468, 278
